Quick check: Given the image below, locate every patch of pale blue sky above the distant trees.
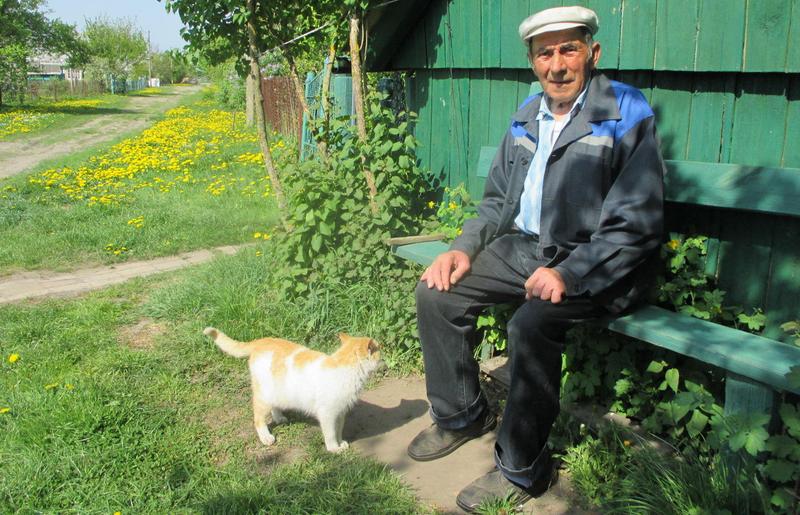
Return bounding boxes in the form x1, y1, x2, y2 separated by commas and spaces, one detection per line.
46, 0, 185, 52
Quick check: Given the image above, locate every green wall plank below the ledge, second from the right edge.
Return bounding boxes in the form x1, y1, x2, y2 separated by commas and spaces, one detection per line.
730, 74, 788, 166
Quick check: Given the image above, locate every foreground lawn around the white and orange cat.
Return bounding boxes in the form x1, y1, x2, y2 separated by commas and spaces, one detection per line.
0, 249, 428, 513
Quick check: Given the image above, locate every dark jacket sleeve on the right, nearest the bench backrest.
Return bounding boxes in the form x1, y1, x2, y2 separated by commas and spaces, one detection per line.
554, 115, 664, 295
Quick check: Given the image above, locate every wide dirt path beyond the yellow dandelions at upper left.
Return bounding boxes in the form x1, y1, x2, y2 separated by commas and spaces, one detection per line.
0, 86, 198, 178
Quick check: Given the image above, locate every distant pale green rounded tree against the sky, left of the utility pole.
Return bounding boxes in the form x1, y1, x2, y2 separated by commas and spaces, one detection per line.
83, 18, 147, 84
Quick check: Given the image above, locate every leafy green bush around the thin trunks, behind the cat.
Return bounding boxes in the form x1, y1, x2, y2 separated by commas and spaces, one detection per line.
266, 96, 428, 366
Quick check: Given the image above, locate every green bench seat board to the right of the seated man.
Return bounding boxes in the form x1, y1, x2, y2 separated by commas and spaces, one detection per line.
608, 306, 800, 393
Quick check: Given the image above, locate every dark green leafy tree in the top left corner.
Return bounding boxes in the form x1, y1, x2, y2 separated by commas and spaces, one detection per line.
0, 0, 88, 105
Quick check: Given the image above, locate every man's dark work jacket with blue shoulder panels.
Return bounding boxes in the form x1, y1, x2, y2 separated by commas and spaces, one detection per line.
450, 74, 665, 313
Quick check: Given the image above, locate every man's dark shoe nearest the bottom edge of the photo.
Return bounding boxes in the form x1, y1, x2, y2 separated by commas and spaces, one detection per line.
456, 468, 558, 513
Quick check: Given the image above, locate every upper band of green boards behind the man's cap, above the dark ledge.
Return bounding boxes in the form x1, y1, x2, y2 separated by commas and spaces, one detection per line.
390, 0, 800, 73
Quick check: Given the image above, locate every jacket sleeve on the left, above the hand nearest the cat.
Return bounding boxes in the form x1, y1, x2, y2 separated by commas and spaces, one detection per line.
450, 126, 514, 260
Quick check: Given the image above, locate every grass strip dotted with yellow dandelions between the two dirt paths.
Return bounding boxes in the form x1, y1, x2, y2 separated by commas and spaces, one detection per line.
0, 89, 287, 273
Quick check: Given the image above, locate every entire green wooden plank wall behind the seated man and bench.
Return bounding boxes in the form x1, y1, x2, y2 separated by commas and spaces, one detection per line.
388, 0, 800, 337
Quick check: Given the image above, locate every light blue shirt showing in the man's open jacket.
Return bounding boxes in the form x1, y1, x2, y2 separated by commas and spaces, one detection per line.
514, 84, 588, 235
